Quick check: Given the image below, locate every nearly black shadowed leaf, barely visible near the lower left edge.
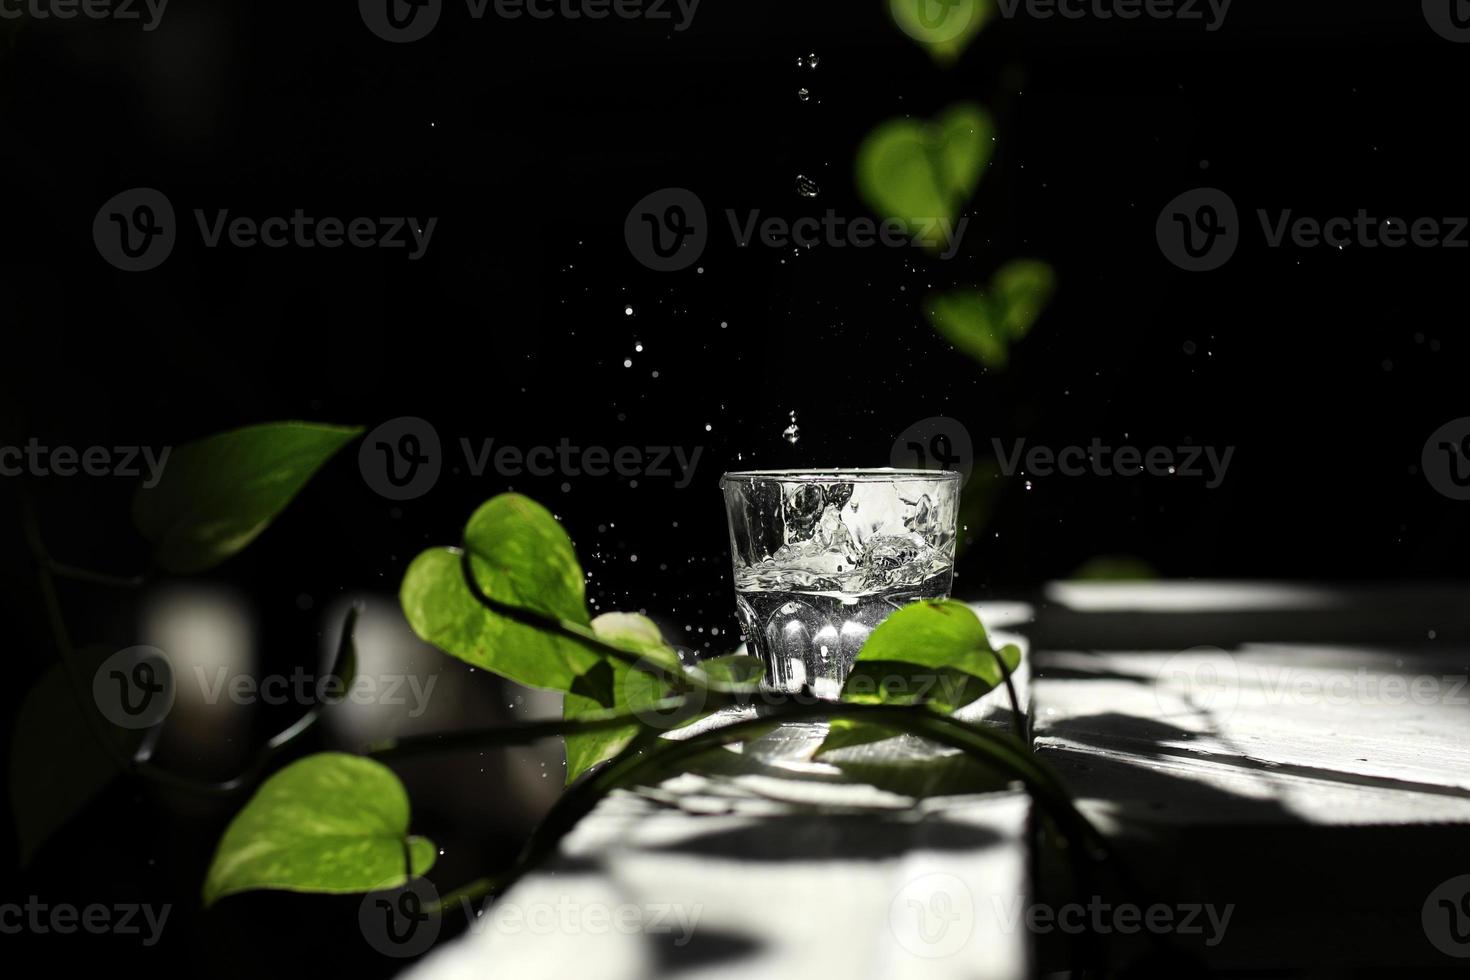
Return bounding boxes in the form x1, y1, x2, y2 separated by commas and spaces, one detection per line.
10, 646, 144, 865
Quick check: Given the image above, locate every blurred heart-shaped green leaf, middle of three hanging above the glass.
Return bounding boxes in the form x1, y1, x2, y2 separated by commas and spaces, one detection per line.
857, 103, 995, 251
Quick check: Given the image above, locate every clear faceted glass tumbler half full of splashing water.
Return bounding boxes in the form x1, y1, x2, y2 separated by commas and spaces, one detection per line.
720, 469, 960, 699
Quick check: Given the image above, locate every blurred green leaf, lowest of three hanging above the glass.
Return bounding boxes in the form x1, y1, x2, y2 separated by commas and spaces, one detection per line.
925, 260, 1057, 370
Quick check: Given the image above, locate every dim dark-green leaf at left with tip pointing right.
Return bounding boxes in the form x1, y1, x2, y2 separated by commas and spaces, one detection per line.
132, 422, 362, 573
